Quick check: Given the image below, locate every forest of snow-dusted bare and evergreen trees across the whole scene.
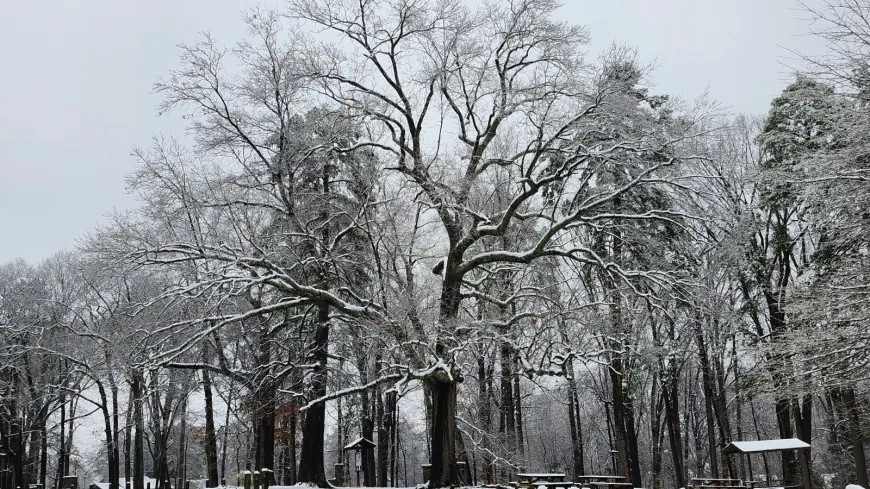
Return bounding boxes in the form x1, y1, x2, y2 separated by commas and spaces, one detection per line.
0, 0, 870, 489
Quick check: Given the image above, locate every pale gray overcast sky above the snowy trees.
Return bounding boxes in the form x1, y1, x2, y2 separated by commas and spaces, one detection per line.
0, 0, 821, 263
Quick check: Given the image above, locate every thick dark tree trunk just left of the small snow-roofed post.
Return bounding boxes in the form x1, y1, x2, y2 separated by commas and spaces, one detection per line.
299, 304, 329, 487
